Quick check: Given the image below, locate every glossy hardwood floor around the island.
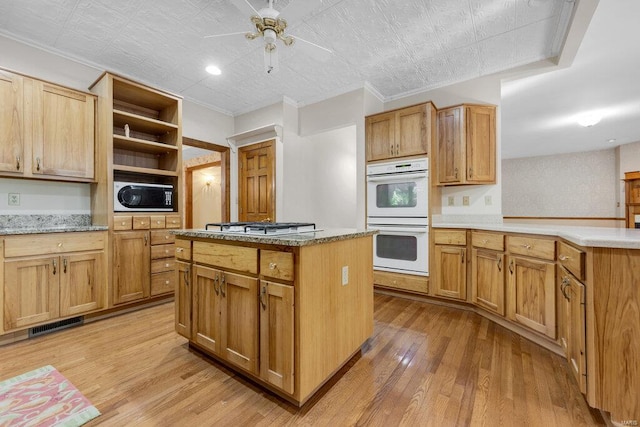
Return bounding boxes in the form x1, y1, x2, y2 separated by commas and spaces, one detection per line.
0, 295, 605, 426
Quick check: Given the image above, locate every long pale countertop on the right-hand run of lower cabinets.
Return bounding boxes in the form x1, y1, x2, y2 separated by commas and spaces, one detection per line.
431, 222, 640, 249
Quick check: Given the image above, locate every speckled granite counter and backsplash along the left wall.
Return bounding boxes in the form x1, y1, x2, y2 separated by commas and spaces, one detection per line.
0, 215, 108, 236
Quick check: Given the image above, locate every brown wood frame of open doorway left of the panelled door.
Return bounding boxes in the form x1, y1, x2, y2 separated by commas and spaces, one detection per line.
182, 136, 231, 228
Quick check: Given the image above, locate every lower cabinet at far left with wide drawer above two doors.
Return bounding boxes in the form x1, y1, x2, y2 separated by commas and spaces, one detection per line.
2, 232, 107, 331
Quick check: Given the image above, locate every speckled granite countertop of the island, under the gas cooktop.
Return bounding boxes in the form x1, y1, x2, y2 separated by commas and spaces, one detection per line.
170, 228, 377, 246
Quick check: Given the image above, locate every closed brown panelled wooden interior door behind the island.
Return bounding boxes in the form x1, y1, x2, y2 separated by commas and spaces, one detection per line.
238, 140, 276, 222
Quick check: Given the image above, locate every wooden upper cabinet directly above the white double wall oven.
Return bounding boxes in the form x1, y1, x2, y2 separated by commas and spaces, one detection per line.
365, 103, 435, 161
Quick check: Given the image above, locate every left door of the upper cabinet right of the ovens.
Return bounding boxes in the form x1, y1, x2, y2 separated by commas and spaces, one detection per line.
437, 107, 464, 184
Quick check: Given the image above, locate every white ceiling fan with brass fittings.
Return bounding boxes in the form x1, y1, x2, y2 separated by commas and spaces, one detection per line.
205, 0, 333, 74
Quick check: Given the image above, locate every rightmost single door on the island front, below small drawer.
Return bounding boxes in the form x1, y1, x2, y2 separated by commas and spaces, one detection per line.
260, 281, 294, 394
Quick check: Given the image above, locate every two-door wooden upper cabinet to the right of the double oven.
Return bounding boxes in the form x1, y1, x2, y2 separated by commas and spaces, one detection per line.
436, 105, 496, 185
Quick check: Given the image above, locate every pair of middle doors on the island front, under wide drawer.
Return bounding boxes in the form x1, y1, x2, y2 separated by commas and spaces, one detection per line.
192, 265, 258, 374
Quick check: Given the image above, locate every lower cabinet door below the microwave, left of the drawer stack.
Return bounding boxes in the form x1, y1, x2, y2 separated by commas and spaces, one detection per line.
113, 231, 150, 304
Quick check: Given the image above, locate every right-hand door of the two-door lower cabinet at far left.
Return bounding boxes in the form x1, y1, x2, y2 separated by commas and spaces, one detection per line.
60, 252, 106, 316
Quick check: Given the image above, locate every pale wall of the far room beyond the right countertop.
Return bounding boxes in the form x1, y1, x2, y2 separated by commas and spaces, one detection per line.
502, 150, 616, 218
